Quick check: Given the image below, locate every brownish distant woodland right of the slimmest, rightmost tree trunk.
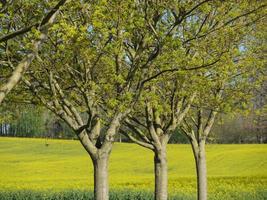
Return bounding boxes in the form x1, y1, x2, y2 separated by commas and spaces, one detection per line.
213, 81, 267, 144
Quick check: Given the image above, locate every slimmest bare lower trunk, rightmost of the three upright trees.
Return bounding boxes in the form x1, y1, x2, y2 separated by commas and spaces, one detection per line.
196, 140, 207, 200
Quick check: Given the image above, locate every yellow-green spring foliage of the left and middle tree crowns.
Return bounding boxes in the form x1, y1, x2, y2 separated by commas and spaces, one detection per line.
3, 1, 262, 120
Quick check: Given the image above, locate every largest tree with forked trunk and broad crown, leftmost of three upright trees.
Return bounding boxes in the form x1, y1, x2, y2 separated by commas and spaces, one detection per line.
15, 1, 184, 200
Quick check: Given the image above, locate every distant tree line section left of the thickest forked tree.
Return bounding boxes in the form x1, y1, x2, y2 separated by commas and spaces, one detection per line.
0, 105, 75, 138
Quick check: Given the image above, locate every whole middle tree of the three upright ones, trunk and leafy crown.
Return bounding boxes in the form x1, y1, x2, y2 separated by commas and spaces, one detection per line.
121, 1, 265, 200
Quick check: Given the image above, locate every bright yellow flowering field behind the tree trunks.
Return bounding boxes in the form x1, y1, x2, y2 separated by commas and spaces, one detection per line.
0, 138, 267, 200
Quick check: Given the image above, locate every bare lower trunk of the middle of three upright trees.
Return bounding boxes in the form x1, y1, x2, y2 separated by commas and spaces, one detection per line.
154, 145, 168, 200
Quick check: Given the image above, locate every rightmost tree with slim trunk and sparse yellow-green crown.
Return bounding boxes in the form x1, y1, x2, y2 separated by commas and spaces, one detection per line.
181, 12, 266, 200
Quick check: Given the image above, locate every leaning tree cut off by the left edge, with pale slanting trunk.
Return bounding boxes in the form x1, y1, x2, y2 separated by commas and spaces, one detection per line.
0, 0, 66, 105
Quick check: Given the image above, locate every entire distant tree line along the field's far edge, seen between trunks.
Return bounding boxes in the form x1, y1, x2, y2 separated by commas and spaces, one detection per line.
0, 105, 267, 144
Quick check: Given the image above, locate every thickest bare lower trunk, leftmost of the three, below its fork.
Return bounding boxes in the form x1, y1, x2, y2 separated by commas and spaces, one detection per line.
93, 156, 109, 200
